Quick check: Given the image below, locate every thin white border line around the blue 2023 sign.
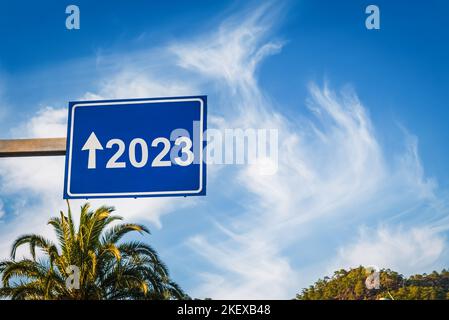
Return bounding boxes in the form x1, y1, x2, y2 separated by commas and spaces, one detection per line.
67, 98, 204, 198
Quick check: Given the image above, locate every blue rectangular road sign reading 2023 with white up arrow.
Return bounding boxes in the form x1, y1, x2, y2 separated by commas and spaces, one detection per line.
64, 96, 207, 199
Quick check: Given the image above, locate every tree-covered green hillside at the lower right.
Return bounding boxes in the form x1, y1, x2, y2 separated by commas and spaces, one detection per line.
296, 266, 449, 300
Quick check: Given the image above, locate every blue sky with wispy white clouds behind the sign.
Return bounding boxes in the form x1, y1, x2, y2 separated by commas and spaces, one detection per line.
0, 1, 449, 298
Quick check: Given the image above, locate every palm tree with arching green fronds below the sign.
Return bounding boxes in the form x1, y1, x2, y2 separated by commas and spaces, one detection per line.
0, 203, 188, 299
